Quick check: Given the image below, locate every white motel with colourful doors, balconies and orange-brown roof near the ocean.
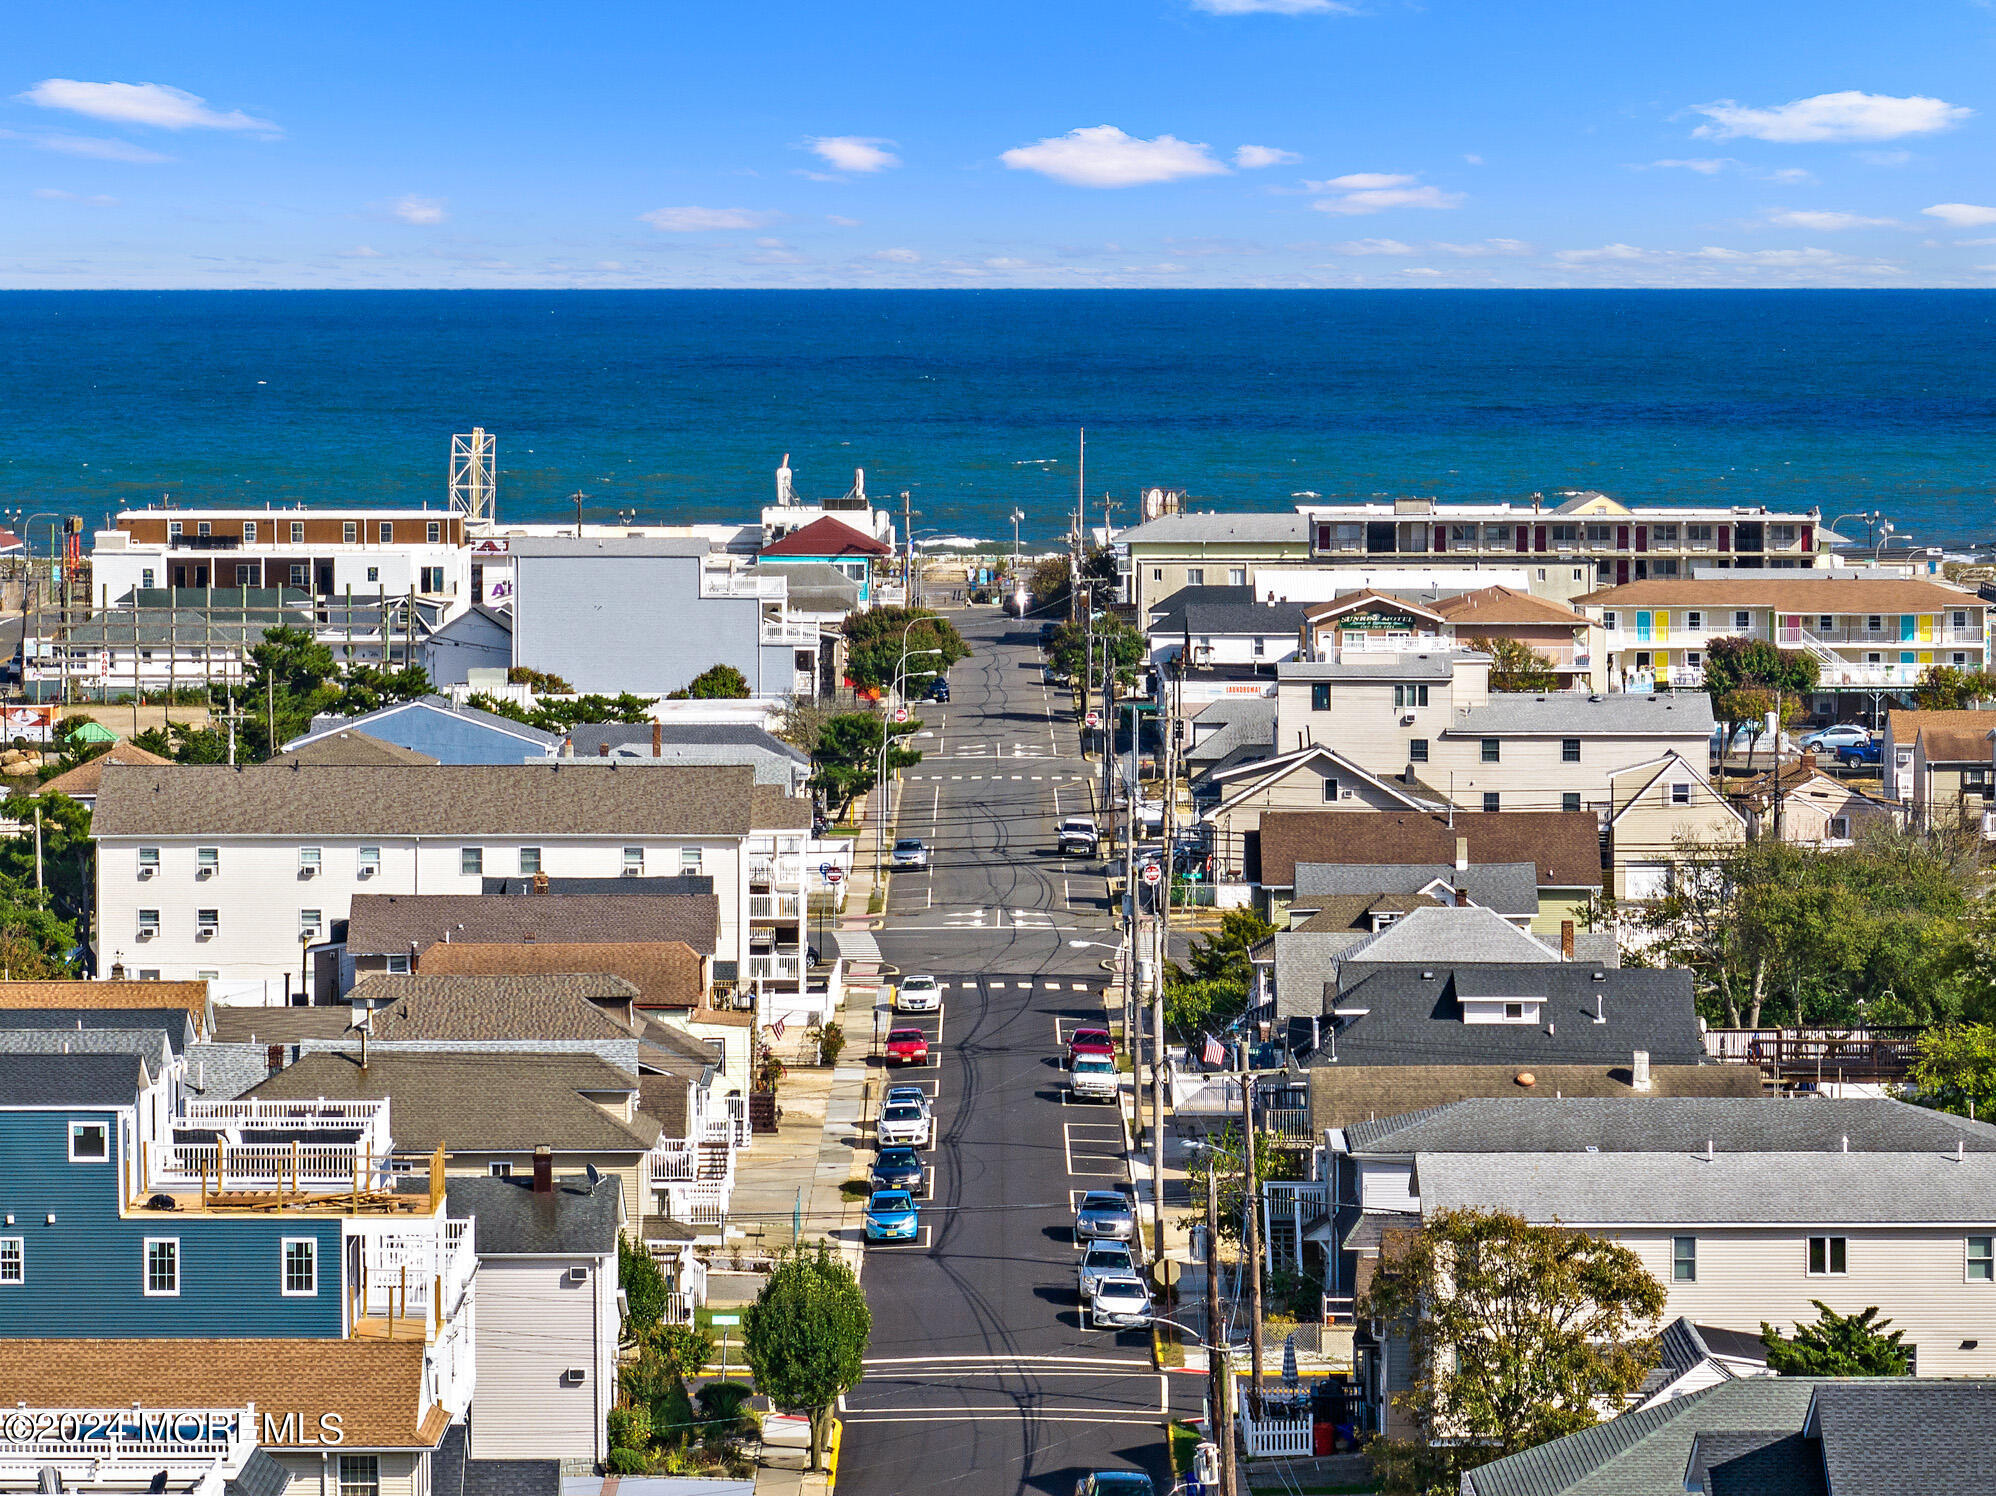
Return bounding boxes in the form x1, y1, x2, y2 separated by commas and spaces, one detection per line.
1575, 573, 1990, 709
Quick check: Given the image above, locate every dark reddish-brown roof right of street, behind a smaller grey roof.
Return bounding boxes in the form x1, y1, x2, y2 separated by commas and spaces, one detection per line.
1261, 811, 1601, 889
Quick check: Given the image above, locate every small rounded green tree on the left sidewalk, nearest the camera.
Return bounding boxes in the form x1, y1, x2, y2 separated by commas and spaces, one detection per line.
743, 1242, 872, 1470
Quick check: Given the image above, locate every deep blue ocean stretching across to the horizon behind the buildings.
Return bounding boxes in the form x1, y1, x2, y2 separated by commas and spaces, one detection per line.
0, 292, 1996, 545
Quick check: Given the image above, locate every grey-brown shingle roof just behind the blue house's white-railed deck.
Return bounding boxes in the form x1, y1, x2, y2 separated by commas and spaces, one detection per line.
250, 1049, 659, 1152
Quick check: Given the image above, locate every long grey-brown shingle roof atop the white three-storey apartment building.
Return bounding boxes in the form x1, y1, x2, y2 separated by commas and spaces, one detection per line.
92, 759, 762, 837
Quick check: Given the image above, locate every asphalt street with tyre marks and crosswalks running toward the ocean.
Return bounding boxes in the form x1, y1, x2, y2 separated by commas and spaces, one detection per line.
838, 613, 1198, 1496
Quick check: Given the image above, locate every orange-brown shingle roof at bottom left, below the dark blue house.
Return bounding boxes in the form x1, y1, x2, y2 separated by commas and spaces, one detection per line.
0, 1336, 449, 1450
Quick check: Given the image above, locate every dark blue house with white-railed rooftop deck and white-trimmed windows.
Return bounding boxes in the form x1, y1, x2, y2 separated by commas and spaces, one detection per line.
0, 1029, 475, 1354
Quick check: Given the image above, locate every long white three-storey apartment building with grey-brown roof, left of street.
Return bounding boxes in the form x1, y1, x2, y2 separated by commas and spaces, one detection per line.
92, 759, 810, 1001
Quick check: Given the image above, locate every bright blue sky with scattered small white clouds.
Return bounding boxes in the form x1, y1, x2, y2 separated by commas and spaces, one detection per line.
11, 0, 1996, 288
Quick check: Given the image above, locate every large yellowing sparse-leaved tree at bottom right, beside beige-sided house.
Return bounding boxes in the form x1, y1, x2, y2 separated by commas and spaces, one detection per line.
1357, 1210, 1667, 1492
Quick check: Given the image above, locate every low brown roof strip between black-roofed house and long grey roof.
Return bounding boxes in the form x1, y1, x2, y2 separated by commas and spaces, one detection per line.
1309, 1065, 1762, 1132
